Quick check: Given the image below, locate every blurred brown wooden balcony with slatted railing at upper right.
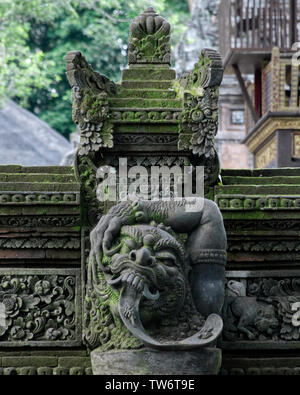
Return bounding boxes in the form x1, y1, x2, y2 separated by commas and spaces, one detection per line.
219, 0, 300, 74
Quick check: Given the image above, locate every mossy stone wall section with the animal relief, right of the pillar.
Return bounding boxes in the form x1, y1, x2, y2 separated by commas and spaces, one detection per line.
215, 168, 300, 375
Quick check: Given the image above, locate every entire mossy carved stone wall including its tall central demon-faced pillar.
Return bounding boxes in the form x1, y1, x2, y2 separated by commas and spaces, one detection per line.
0, 8, 300, 375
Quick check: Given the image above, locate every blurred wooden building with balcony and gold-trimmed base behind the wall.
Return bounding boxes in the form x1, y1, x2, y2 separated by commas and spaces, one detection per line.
219, 0, 300, 168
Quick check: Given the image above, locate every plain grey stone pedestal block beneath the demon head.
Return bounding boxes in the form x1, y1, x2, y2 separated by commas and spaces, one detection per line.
91, 348, 222, 375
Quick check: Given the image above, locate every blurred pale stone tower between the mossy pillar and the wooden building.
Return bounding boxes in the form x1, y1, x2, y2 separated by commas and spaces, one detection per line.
173, 0, 253, 169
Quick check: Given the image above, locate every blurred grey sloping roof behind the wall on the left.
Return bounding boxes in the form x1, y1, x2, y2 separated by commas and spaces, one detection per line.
0, 100, 72, 166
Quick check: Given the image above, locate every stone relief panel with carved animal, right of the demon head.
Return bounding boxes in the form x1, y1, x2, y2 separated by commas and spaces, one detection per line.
222, 270, 300, 348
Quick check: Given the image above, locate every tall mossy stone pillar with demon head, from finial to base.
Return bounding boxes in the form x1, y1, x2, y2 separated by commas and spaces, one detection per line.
66, 8, 226, 374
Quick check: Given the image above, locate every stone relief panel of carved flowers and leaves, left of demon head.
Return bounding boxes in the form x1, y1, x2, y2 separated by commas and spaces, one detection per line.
0, 268, 81, 347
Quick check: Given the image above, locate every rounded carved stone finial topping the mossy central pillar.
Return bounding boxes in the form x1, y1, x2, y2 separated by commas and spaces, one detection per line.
128, 7, 171, 64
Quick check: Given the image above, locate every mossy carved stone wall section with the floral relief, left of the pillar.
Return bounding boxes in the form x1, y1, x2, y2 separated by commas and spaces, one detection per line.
0, 166, 91, 375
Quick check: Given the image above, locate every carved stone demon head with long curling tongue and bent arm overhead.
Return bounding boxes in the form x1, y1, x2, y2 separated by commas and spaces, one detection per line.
84, 199, 226, 351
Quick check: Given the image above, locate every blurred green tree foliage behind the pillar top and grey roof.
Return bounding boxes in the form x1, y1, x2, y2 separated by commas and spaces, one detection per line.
0, 0, 189, 136
